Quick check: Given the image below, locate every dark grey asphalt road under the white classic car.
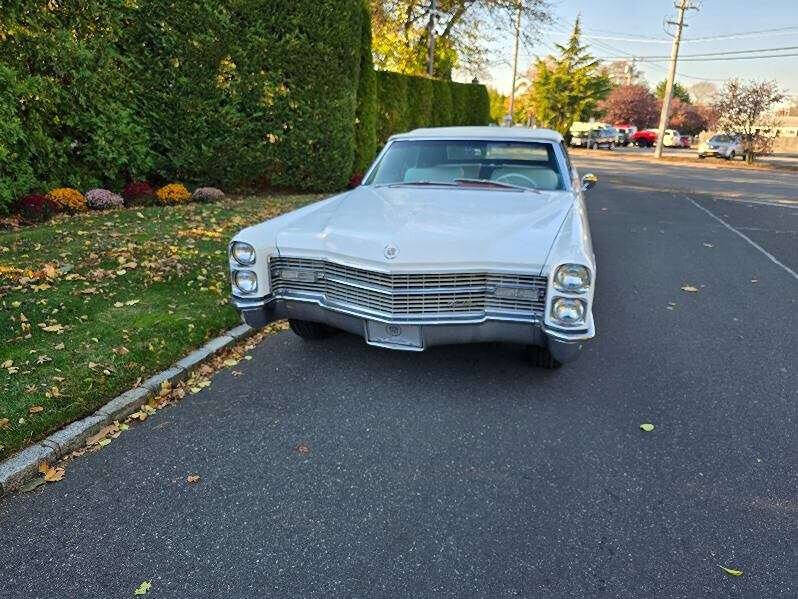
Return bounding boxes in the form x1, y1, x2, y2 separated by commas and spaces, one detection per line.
0, 160, 798, 599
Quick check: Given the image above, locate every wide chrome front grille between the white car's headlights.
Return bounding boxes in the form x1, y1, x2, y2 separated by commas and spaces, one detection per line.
269, 257, 547, 320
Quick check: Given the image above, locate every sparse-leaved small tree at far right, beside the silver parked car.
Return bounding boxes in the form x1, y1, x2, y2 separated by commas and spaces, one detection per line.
713, 79, 786, 164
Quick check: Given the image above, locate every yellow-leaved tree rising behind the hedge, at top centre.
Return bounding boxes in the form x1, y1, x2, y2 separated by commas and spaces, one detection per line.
369, 0, 551, 78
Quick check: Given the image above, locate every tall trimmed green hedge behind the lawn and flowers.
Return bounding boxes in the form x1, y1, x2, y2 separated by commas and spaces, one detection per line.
0, 0, 488, 213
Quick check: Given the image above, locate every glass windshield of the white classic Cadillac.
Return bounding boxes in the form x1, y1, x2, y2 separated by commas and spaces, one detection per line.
364, 140, 565, 191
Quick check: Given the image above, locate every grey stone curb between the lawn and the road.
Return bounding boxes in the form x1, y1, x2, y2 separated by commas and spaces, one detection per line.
0, 324, 255, 497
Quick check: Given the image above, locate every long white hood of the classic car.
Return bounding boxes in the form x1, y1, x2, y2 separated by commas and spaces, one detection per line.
275, 186, 574, 272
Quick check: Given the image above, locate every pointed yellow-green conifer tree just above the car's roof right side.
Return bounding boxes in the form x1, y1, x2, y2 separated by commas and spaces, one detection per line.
528, 18, 612, 134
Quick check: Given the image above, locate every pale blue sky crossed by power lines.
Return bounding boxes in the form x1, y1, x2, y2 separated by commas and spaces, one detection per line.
485, 0, 798, 97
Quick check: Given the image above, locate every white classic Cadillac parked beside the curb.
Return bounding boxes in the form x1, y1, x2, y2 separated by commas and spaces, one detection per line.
229, 127, 597, 368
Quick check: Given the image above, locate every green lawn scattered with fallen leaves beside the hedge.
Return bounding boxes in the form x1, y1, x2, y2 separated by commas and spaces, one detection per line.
0, 195, 319, 459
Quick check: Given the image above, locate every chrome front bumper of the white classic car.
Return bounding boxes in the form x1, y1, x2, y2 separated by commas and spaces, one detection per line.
232, 296, 593, 363
